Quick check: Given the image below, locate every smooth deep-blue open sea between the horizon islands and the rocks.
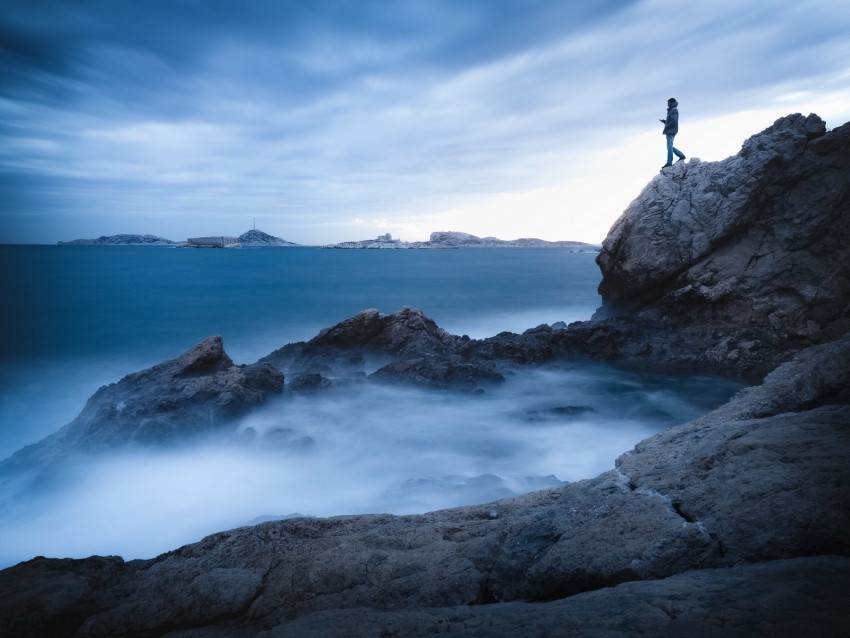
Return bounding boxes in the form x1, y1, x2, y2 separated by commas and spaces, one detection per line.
0, 246, 600, 458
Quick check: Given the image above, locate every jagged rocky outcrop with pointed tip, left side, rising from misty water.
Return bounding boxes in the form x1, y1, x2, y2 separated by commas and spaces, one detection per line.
0, 337, 284, 476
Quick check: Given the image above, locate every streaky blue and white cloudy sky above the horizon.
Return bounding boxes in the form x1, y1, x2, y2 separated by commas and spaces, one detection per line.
0, 0, 850, 244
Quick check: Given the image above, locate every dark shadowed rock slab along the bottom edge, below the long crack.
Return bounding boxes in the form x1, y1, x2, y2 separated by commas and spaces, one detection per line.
262, 556, 850, 638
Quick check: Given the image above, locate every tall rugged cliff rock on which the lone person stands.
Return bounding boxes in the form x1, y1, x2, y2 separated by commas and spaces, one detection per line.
597, 114, 850, 369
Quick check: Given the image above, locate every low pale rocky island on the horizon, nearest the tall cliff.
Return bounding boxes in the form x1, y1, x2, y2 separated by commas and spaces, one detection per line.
323, 231, 600, 252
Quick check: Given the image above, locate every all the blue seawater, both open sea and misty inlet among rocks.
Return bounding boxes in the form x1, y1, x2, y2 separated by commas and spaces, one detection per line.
0, 246, 738, 566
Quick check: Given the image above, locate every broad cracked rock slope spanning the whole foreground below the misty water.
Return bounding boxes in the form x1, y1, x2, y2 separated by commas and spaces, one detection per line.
0, 337, 850, 636
